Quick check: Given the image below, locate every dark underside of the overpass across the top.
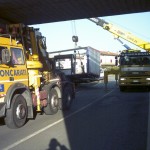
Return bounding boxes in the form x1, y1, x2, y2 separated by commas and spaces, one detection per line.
0, 0, 150, 25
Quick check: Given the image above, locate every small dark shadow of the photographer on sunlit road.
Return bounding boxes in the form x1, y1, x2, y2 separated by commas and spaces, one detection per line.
47, 139, 69, 150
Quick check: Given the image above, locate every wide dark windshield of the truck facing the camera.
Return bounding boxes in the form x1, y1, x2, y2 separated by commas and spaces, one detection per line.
120, 56, 150, 65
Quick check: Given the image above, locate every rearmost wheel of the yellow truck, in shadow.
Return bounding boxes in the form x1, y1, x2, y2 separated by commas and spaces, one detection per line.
62, 88, 73, 110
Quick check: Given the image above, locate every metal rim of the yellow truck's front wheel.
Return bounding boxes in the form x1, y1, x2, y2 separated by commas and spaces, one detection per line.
16, 104, 26, 119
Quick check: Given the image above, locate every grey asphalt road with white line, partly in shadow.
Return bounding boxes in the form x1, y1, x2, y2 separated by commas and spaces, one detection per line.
0, 78, 150, 150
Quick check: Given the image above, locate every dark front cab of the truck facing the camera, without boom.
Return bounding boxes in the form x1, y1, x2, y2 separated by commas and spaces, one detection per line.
119, 50, 150, 91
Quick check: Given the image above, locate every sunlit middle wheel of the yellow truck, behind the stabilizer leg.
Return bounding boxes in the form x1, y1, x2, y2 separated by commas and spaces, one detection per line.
43, 89, 59, 115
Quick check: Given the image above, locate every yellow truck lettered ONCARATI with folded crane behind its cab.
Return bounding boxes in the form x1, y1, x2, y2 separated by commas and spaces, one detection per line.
0, 24, 75, 128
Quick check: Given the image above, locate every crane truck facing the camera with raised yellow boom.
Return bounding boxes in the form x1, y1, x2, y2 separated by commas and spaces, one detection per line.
89, 17, 150, 91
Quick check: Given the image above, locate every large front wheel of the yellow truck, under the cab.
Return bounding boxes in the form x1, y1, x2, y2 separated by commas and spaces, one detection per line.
5, 94, 27, 129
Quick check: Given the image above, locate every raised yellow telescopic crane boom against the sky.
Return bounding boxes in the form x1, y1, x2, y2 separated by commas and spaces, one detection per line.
89, 17, 150, 51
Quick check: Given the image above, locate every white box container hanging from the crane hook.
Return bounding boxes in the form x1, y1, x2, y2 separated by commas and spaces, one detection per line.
49, 47, 100, 80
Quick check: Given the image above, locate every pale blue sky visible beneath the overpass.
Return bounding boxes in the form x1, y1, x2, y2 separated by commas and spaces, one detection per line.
32, 12, 150, 53
